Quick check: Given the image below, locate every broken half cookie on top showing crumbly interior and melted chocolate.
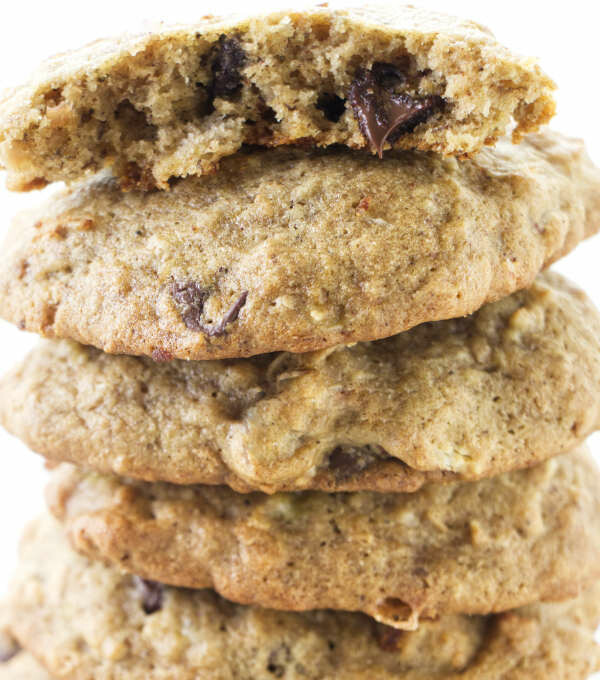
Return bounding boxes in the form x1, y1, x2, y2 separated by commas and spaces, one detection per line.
0, 6, 555, 190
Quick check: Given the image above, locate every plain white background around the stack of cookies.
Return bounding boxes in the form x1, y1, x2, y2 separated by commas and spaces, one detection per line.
0, 0, 600, 668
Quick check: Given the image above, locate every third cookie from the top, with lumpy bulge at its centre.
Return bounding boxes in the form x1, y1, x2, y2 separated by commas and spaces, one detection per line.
0, 273, 600, 493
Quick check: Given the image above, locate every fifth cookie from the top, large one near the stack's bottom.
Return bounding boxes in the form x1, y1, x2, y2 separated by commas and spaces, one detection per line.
11, 520, 600, 680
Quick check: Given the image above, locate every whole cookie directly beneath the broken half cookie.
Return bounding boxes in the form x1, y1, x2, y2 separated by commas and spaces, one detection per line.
0, 132, 600, 360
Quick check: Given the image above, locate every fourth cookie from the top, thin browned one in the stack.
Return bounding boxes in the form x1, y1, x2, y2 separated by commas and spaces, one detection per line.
47, 450, 600, 630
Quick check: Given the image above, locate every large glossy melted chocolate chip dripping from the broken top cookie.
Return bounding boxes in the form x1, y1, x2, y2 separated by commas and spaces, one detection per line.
349, 63, 443, 158
